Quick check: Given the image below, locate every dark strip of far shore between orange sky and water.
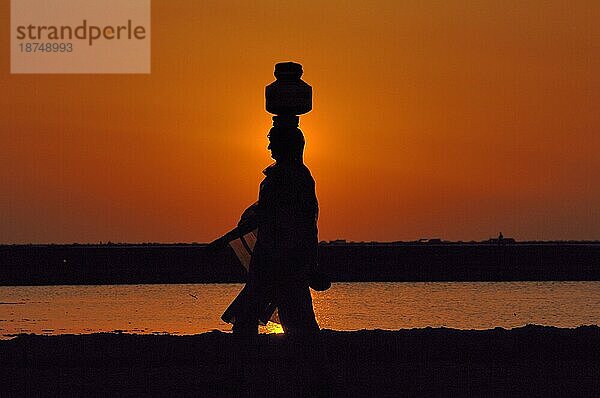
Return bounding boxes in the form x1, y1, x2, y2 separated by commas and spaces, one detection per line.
0, 238, 600, 286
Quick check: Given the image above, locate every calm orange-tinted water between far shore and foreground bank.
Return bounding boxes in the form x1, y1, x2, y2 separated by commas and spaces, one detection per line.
0, 282, 600, 338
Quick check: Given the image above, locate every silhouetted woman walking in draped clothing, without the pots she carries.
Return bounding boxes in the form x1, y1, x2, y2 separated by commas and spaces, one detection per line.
230, 124, 319, 335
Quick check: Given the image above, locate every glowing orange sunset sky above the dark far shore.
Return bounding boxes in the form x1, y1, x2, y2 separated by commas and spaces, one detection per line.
0, 0, 600, 243
